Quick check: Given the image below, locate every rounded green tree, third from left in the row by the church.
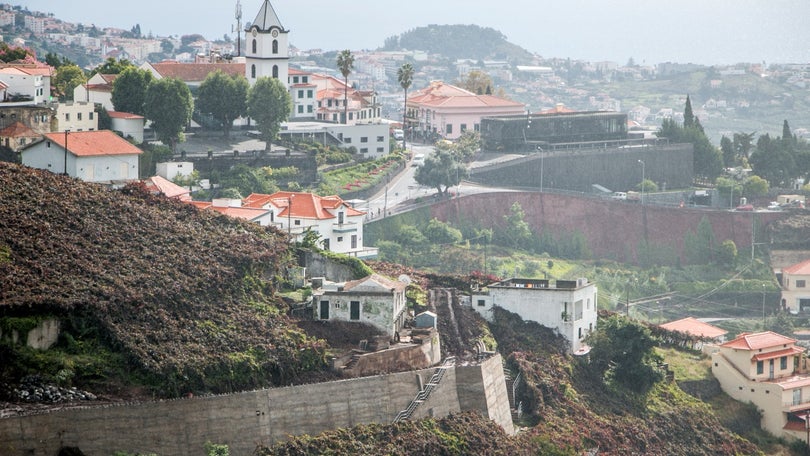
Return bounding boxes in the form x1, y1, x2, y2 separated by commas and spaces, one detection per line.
197, 70, 249, 138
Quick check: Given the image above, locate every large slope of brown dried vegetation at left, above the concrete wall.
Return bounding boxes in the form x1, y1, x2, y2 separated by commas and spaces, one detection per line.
0, 163, 324, 395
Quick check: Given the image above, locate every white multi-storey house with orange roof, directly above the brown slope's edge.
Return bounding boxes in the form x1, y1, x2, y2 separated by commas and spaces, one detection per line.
242, 192, 377, 258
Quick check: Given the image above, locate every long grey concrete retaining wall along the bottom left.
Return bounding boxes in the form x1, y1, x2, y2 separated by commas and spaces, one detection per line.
0, 355, 504, 456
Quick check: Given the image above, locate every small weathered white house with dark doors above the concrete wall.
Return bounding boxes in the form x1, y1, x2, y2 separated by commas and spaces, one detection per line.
312, 274, 407, 337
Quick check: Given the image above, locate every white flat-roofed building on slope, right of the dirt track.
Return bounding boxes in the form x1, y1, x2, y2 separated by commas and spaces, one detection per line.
470, 278, 597, 353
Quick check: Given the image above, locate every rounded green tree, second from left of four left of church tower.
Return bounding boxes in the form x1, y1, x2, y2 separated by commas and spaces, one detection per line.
144, 78, 194, 152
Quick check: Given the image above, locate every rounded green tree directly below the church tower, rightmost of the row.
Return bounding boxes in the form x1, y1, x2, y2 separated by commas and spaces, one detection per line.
247, 76, 292, 150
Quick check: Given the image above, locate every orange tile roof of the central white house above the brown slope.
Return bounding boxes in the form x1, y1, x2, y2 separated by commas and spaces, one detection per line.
242, 192, 365, 220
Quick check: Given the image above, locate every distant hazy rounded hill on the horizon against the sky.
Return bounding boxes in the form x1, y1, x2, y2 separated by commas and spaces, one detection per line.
382, 24, 532, 64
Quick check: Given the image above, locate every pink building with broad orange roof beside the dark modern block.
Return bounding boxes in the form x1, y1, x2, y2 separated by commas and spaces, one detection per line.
405, 81, 526, 140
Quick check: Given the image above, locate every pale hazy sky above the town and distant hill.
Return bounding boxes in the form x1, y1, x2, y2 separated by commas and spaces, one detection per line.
12, 0, 810, 64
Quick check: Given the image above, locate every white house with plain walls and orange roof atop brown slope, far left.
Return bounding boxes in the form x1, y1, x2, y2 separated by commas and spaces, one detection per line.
20, 130, 141, 183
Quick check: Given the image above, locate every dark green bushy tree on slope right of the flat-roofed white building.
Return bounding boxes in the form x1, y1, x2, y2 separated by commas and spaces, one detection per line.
588, 315, 663, 393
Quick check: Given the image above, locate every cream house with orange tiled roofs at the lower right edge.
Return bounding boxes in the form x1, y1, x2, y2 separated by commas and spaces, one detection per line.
712, 331, 810, 440
